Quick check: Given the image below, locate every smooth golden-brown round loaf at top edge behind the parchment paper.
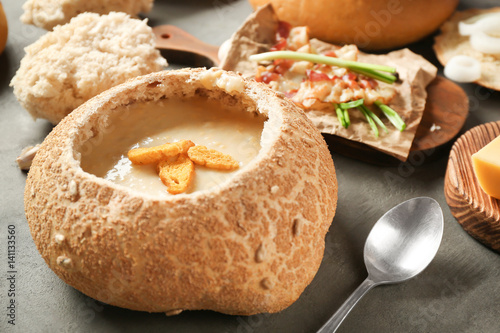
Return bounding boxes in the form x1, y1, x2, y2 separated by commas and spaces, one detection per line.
249, 0, 458, 50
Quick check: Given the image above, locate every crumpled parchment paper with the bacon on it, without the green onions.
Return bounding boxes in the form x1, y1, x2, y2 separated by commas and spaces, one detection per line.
220, 5, 437, 161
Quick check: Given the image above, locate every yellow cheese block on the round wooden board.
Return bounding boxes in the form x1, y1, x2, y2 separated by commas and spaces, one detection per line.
472, 136, 500, 199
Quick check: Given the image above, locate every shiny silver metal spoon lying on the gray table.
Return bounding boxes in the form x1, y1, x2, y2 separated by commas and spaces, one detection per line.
318, 197, 443, 333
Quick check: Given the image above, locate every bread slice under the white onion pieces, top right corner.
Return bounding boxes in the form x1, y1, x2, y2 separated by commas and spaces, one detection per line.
434, 7, 500, 90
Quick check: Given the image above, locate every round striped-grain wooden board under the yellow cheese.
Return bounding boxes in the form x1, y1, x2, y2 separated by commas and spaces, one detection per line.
444, 122, 500, 253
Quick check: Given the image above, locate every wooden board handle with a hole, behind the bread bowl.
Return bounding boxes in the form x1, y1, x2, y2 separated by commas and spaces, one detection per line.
153, 25, 219, 66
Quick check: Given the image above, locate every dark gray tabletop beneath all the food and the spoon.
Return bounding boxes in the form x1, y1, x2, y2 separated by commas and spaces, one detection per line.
0, 0, 500, 333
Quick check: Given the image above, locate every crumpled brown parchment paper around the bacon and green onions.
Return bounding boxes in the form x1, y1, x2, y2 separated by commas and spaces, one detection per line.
220, 5, 437, 161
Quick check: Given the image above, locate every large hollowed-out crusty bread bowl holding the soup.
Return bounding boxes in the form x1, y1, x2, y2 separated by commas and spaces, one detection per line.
24, 69, 337, 315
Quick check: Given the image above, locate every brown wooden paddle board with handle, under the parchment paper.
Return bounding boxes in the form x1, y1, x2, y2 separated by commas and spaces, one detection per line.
153, 25, 469, 165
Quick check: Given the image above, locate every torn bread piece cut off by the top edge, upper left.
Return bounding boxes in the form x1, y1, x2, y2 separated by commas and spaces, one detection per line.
21, 0, 153, 30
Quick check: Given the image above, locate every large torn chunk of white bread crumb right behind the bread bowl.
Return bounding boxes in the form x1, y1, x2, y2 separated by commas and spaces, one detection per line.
11, 12, 167, 124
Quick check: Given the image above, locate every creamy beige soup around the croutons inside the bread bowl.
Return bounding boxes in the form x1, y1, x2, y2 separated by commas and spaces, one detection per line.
81, 98, 266, 196
